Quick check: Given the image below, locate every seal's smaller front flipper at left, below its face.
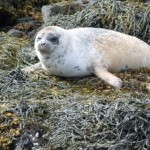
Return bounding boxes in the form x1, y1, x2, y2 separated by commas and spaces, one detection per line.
21, 63, 43, 74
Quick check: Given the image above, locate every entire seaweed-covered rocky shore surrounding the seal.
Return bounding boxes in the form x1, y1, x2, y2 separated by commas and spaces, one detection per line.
0, 0, 150, 150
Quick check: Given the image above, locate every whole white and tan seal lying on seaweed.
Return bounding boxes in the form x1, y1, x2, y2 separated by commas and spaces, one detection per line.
23, 26, 150, 88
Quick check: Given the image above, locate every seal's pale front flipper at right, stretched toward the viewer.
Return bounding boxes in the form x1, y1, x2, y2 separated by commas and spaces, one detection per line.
94, 68, 122, 89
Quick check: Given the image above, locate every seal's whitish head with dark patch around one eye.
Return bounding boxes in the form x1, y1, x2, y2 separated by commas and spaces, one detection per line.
35, 26, 69, 57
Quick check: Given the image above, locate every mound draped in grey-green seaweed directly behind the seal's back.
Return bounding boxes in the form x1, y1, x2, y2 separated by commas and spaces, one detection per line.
44, 0, 150, 42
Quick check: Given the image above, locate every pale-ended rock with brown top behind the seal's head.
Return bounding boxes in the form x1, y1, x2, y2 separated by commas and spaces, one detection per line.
41, 2, 83, 23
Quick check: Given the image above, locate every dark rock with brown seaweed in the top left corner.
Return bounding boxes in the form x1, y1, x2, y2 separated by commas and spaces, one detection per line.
0, 0, 79, 27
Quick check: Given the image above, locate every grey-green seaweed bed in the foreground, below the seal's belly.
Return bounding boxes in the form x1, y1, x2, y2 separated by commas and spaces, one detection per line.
0, 70, 150, 150
